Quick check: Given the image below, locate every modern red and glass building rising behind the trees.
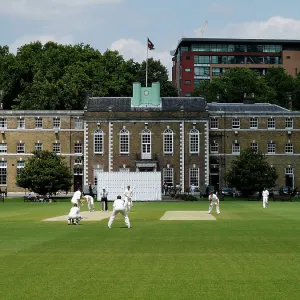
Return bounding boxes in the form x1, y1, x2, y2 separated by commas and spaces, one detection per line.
171, 38, 300, 96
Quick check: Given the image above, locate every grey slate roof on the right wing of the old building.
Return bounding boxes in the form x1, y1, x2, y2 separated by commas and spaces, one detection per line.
207, 102, 293, 114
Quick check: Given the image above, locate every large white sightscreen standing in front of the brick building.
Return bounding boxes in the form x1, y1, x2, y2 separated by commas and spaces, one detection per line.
97, 172, 161, 201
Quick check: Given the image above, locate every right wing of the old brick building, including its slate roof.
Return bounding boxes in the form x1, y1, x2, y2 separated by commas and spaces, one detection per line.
208, 103, 300, 188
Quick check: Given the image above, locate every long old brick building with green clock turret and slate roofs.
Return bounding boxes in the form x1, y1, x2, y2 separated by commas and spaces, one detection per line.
0, 83, 300, 193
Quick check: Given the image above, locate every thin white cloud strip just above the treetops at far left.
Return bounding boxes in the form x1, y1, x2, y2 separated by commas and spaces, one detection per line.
9, 35, 74, 53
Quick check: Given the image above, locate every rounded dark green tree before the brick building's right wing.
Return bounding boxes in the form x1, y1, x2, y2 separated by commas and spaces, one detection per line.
225, 148, 278, 195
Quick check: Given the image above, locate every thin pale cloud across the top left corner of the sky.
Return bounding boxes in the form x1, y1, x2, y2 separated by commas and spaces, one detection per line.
0, 0, 123, 20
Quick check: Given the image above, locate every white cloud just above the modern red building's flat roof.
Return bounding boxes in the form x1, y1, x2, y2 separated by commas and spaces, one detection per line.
195, 16, 300, 39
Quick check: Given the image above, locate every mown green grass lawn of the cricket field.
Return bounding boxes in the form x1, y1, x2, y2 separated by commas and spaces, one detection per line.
0, 199, 300, 300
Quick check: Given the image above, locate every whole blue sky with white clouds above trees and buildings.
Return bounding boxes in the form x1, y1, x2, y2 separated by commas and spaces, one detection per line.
0, 0, 300, 78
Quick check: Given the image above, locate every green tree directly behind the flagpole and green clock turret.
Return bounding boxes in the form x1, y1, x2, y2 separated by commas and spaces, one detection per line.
136, 58, 178, 97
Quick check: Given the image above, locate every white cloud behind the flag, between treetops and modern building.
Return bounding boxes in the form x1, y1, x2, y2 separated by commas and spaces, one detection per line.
110, 39, 173, 77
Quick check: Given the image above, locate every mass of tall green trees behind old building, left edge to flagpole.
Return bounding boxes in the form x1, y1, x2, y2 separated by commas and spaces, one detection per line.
0, 42, 177, 110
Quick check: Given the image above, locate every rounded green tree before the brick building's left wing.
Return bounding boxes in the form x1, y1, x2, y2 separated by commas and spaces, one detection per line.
17, 151, 72, 195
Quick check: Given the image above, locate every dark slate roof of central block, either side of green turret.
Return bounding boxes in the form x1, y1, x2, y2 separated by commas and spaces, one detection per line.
87, 97, 206, 112
